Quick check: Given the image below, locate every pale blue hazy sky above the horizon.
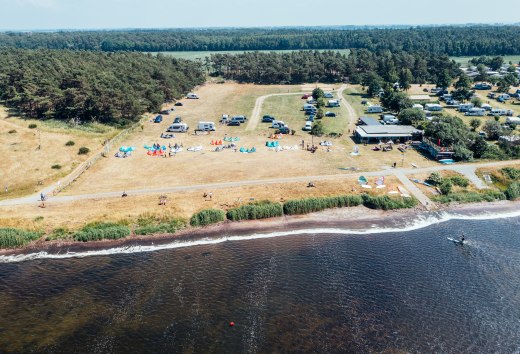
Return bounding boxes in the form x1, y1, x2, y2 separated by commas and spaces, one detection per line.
0, 0, 520, 30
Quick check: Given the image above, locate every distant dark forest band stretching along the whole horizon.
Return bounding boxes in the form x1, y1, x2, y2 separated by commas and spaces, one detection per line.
0, 25, 520, 56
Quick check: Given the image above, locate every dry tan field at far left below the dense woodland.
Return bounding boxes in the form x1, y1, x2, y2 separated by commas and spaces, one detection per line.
0, 106, 118, 199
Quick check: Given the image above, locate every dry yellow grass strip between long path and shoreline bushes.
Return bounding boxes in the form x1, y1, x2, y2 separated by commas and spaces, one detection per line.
0, 176, 399, 231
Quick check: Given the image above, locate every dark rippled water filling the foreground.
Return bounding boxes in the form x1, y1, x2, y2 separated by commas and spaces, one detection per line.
0, 218, 520, 353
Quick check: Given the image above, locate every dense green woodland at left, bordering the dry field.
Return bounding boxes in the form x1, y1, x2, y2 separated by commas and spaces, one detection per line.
0, 49, 205, 125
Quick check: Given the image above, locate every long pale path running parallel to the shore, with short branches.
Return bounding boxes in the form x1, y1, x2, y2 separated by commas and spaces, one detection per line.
0, 160, 520, 206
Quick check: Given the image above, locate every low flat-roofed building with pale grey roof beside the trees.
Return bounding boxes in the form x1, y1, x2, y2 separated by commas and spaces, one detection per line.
354, 124, 422, 143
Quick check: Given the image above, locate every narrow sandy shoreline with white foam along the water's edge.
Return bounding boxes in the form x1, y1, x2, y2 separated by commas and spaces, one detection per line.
0, 201, 520, 257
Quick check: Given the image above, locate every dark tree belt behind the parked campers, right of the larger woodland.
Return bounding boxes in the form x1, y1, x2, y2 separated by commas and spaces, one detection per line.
211, 49, 460, 87
